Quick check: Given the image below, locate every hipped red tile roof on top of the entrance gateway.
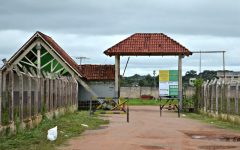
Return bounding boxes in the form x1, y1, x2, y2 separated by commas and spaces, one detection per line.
104, 33, 192, 56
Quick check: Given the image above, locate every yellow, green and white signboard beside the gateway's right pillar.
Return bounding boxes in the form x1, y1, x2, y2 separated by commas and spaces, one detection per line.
159, 70, 178, 97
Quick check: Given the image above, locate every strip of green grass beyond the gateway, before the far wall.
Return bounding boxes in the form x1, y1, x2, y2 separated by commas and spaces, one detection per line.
128, 99, 178, 106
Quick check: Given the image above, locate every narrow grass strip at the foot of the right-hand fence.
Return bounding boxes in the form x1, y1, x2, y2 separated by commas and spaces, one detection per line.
186, 113, 240, 131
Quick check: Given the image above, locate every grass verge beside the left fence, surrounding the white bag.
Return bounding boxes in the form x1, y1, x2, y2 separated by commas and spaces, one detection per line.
0, 111, 108, 150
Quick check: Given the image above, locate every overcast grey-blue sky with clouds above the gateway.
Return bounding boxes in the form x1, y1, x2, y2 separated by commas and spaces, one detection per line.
0, 0, 240, 76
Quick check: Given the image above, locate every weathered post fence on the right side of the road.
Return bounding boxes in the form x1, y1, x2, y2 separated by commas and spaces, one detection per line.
198, 79, 240, 115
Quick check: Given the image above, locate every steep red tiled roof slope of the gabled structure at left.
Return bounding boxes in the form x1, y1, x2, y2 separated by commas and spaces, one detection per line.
37, 31, 82, 75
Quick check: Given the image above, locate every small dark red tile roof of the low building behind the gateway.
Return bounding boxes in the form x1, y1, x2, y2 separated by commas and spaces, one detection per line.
79, 65, 115, 80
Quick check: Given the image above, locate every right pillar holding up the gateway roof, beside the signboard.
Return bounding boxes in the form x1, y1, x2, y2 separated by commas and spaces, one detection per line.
178, 55, 183, 112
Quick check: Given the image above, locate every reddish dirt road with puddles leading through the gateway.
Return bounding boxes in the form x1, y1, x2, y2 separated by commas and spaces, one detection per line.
59, 106, 240, 150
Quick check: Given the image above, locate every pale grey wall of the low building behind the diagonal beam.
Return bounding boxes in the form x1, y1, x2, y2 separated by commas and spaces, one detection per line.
78, 81, 114, 101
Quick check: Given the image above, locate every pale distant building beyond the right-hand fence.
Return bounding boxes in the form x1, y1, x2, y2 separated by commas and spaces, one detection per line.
217, 71, 240, 81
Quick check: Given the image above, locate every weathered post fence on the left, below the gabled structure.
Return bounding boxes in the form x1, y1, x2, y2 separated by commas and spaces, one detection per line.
0, 67, 78, 126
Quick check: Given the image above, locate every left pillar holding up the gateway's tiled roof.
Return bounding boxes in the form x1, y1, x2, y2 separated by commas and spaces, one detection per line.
114, 55, 120, 97
